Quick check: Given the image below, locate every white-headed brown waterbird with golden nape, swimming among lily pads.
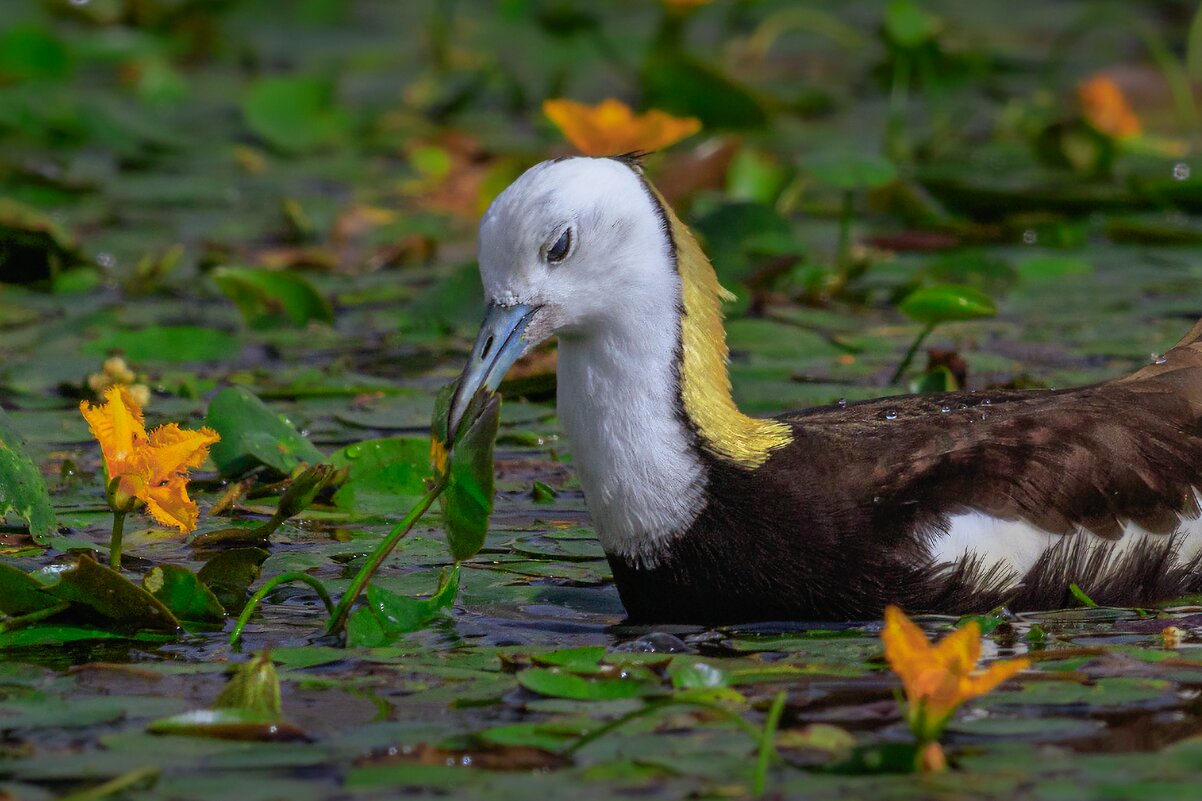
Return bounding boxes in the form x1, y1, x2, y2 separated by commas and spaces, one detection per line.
451, 156, 1202, 625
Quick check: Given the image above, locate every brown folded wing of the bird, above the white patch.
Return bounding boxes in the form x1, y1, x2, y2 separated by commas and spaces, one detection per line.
783, 324, 1202, 539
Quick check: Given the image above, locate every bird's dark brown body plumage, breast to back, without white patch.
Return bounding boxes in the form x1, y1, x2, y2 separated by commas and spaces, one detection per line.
611, 322, 1202, 623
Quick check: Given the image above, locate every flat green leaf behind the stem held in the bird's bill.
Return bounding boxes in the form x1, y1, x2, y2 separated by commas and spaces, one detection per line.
329, 437, 430, 514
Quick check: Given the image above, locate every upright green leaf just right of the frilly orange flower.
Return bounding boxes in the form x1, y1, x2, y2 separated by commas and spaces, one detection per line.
204, 387, 325, 476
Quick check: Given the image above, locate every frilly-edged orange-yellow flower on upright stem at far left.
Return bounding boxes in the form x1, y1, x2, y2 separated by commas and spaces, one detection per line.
79, 386, 221, 532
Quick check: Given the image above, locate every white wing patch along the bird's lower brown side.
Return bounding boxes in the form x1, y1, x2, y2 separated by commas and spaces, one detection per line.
930, 493, 1202, 583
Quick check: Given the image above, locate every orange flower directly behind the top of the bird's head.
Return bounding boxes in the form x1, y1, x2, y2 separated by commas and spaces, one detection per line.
542, 99, 701, 156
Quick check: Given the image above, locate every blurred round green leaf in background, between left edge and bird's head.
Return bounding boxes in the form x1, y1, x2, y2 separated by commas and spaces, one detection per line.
242, 76, 349, 154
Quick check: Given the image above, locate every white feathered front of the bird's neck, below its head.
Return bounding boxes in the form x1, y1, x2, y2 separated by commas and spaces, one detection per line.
558, 297, 707, 568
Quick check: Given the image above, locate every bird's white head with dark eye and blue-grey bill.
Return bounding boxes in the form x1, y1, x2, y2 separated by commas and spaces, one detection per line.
452, 158, 680, 425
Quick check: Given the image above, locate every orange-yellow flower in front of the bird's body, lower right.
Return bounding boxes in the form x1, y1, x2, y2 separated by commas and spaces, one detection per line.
881, 606, 1030, 743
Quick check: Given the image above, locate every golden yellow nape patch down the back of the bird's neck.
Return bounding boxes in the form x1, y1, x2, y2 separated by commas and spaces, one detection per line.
656, 192, 793, 468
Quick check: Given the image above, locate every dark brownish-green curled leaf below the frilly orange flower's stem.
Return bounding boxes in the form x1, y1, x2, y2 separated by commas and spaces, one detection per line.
42, 554, 179, 631
